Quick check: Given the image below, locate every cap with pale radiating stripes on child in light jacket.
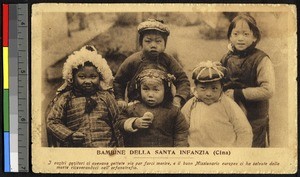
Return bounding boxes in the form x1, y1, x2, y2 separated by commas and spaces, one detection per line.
192, 61, 227, 82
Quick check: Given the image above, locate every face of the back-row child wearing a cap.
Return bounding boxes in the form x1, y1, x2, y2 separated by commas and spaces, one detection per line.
142, 33, 166, 56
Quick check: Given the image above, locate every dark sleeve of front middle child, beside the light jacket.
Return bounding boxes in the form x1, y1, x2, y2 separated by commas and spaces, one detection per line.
174, 109, 189, 147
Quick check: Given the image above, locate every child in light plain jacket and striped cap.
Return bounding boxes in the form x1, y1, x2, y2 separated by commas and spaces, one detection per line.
182, 61, 252, 147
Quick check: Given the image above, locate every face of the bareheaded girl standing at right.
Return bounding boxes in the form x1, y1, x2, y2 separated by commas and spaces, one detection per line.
230, 20, 256, 51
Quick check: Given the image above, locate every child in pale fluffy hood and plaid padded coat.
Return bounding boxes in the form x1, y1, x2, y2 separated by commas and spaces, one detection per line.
46, 46, 122, 147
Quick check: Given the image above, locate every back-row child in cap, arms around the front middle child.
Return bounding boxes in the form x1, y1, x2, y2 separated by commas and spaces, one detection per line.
114, 19, 190, 109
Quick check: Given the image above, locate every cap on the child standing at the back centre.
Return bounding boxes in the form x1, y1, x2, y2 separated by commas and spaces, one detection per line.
138, 18, 170, 36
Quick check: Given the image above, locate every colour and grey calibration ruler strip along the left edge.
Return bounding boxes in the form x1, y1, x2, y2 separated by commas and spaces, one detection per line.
2, 4, 29, 172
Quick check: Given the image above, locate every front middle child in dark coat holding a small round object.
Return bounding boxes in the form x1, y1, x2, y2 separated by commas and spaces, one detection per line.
117, 69, 188, 147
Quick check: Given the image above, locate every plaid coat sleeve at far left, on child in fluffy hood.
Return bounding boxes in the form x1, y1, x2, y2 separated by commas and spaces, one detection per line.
46, 93, 74, 143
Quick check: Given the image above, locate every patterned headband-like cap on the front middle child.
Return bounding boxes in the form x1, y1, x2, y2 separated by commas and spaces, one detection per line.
136, 69, 176, 86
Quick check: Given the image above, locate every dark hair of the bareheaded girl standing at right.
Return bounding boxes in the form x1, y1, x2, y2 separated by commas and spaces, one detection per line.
227, 14, 261, 46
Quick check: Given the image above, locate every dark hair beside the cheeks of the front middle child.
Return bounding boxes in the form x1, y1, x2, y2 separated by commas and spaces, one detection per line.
136, 80, 174, 106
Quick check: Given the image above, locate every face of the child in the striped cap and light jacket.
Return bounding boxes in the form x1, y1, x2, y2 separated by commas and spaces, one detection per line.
196, 81, 222, 105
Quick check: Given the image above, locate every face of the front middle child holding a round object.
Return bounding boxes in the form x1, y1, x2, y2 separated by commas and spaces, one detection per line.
141, 78, 165, 107
